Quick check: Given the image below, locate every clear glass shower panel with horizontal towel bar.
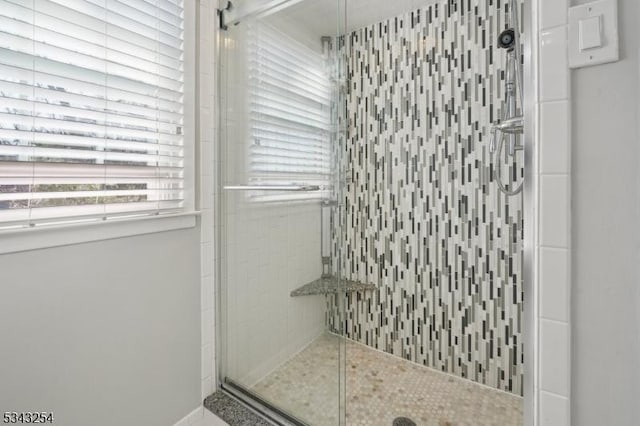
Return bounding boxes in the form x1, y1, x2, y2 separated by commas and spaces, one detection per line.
220, 0, 345, 425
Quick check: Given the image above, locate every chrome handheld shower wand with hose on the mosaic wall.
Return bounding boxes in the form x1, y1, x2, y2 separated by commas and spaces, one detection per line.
489, 1, 524, 196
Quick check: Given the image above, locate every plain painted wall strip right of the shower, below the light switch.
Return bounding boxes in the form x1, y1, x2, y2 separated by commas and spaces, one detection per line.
572, 0, 640, 426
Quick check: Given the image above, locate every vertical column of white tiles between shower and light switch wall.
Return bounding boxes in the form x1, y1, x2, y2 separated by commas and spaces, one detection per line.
534, 0, 571, 426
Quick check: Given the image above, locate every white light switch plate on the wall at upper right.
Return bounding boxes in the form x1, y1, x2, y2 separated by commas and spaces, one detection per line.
569, 0, 620, 68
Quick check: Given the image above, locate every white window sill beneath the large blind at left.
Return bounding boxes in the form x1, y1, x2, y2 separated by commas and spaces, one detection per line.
0, 211, 200, 255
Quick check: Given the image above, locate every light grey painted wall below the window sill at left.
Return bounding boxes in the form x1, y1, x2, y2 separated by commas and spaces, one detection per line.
0, 227, 200, 426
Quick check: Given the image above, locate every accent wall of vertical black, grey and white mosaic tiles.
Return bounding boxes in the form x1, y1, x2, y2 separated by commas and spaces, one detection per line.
327, 0, 524, 394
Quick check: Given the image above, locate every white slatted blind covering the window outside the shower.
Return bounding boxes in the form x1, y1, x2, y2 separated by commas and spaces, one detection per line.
0, 0, 184, 227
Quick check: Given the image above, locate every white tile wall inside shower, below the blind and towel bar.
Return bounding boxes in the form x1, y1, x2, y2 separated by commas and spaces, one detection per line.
226, 203, 325, 386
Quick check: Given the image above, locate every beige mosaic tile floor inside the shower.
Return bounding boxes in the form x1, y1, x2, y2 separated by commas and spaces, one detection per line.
252, 334, 523, 426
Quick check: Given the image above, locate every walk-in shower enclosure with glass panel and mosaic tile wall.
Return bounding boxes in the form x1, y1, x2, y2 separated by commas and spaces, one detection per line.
218, 0, 525, 425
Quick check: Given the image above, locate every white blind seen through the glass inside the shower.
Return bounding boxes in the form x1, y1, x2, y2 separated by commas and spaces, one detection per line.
249, 23, 332, 201
